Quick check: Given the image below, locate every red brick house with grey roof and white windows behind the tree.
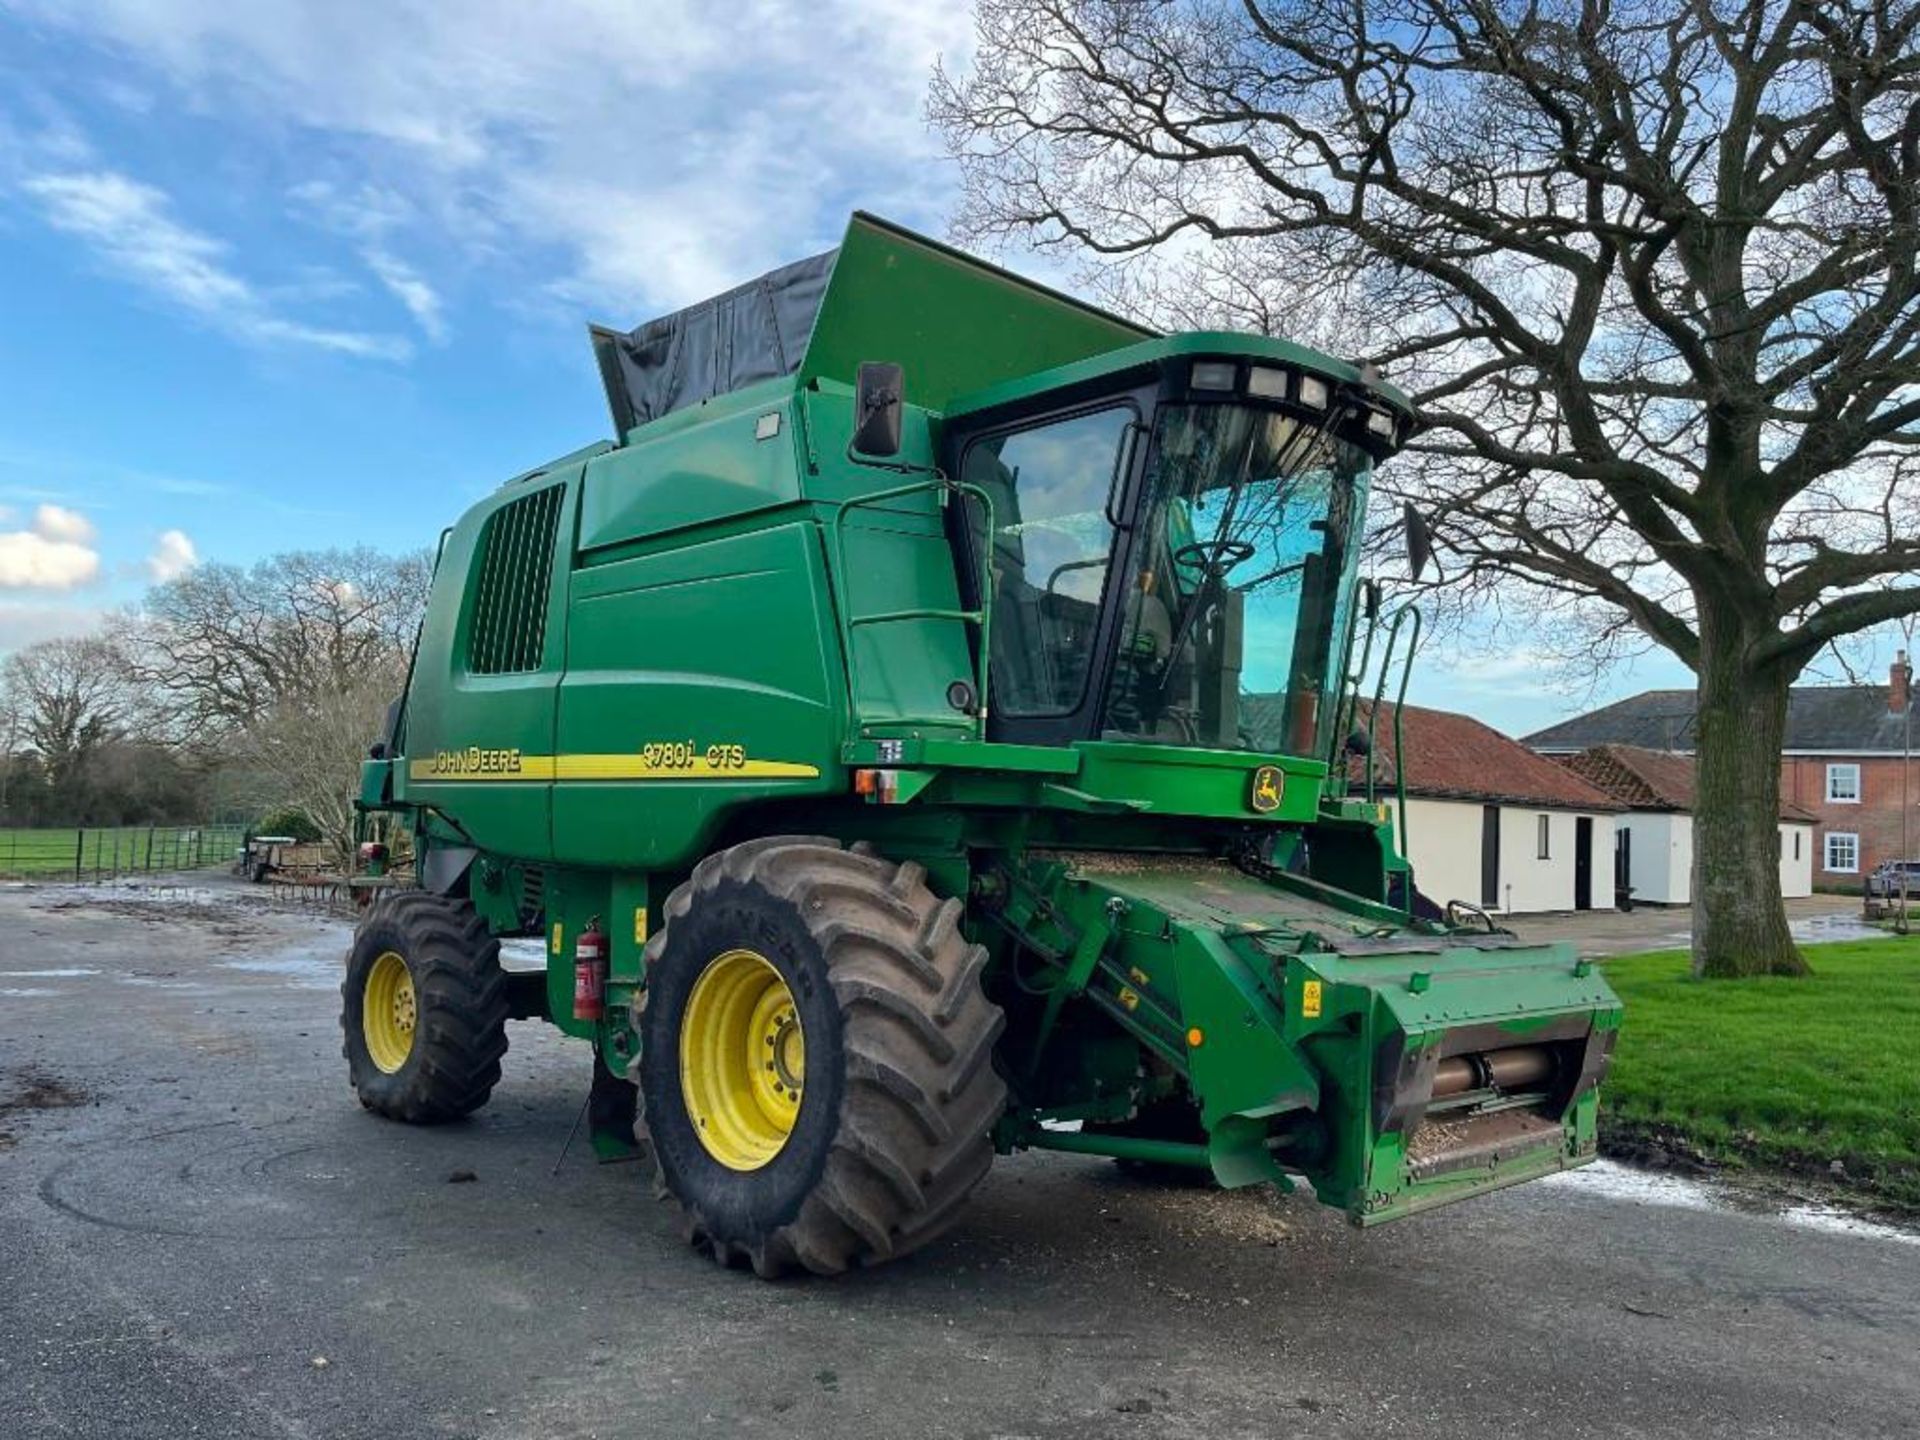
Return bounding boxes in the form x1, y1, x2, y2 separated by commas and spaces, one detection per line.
1526, 651, 1920, 889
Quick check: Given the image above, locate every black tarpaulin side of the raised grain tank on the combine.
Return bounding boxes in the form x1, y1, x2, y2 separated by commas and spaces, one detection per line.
593, 250, 839, 436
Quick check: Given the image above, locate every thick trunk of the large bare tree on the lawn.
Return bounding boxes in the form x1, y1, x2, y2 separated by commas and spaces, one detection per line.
1693, 607, 1809, 979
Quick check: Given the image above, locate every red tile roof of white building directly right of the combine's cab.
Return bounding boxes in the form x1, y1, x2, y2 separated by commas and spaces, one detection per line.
1352, 705, 1626, 810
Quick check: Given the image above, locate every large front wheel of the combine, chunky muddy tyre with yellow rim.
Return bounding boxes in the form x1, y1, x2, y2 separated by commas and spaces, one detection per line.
639, 835, 1006, 1279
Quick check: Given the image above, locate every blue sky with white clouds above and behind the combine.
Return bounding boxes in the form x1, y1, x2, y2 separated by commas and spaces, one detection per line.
0, 0, 1866, 733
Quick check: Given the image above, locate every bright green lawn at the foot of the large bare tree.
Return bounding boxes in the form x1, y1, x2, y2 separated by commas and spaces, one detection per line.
1601, 937, 1920, 1210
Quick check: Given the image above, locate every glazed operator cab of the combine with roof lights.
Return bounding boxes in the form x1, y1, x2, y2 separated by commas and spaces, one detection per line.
945, 336, 1413, 756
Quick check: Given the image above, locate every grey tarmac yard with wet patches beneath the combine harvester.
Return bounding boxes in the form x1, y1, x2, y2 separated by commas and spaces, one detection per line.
0, 887, 1920, 1440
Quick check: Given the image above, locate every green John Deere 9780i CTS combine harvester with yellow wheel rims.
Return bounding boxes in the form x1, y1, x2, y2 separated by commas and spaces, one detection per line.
344, 215, 1620, 1275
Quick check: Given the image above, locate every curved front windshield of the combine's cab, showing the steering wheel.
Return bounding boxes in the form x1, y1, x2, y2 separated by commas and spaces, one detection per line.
1104, 405, 1371, 756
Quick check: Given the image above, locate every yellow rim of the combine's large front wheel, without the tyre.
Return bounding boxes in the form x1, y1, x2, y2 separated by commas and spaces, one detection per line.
680, 950, 806, 1171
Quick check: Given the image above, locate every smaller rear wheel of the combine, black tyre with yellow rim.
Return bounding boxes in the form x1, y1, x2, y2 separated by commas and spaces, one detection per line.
340, 891, 507, 1125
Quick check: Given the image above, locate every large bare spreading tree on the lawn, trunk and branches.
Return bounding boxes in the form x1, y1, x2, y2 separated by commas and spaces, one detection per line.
931, 0, 1920, 975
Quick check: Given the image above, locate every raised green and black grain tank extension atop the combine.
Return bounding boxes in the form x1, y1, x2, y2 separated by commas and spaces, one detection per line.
591, 213, 1154, 440
